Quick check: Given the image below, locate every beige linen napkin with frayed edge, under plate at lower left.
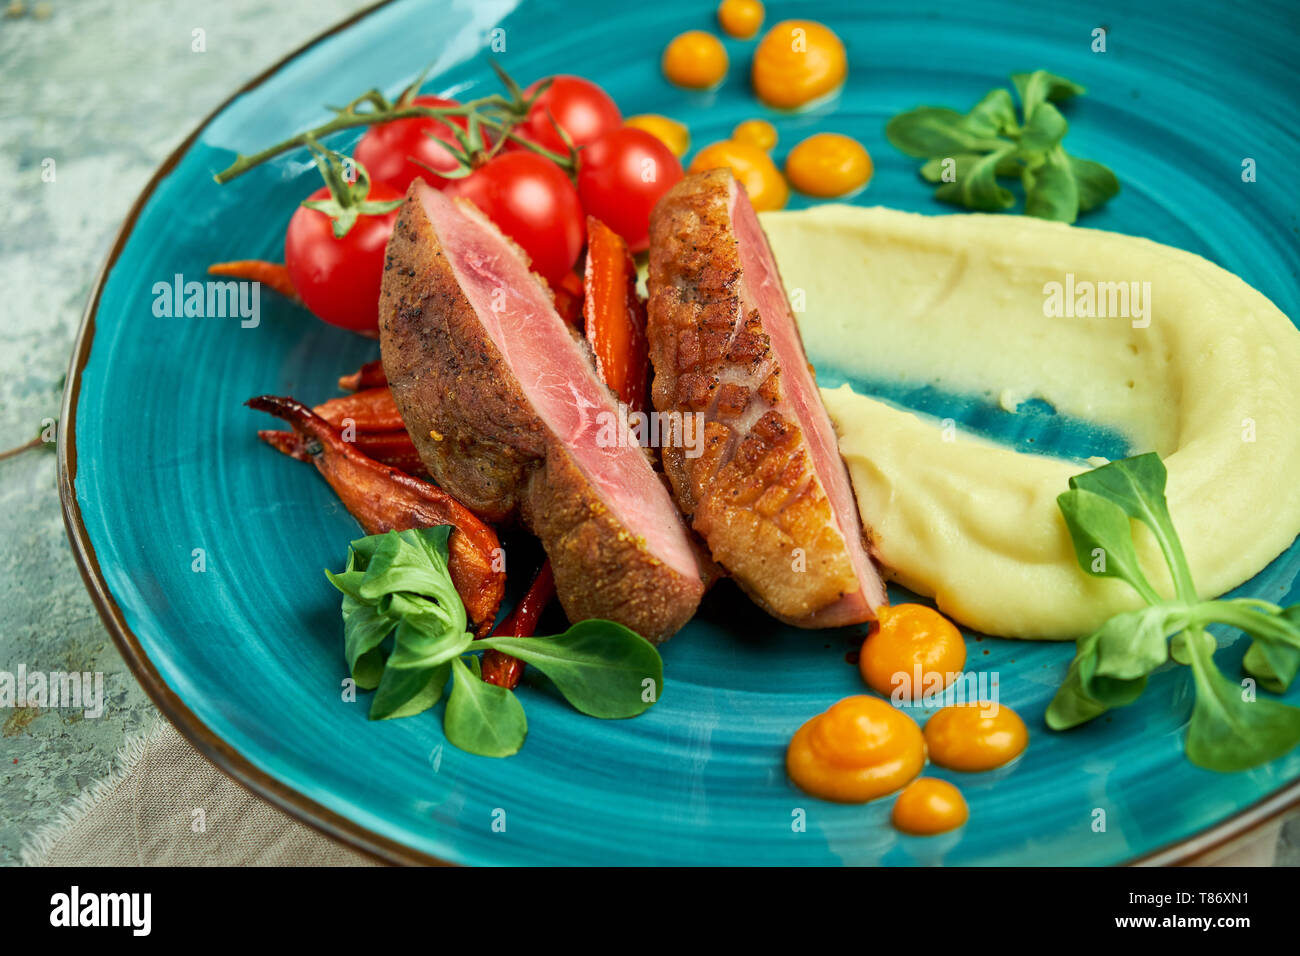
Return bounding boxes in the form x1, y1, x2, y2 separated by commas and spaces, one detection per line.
22, 718, 374, 866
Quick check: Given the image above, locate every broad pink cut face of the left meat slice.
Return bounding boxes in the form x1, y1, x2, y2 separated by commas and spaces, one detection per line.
420, 186, 699, 576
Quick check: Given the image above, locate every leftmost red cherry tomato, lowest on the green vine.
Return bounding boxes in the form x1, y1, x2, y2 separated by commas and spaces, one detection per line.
285, 183, 402, 333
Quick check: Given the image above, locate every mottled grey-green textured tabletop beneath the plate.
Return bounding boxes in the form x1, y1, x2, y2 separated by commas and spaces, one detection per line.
0, 0, 1300, 865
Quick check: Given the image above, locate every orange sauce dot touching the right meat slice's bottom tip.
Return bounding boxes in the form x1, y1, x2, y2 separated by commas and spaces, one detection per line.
858, 604, 966, 700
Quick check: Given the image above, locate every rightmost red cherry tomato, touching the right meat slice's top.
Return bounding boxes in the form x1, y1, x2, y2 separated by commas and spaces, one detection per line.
577, 126, 681, 252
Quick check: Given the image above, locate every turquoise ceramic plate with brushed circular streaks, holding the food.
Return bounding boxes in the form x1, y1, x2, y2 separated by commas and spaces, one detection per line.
61, 0, 1300, 864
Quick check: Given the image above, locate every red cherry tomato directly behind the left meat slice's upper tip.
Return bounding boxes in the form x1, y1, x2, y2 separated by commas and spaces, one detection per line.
446, 152, 586, 286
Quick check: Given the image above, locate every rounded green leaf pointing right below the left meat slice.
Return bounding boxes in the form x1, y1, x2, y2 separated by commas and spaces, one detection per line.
476, 620, 663, 718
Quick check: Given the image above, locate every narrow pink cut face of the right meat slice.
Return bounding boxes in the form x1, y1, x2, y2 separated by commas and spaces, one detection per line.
731, 181, 885, 619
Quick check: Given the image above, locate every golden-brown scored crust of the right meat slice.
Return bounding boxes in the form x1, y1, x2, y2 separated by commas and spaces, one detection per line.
647, 169, 861, 627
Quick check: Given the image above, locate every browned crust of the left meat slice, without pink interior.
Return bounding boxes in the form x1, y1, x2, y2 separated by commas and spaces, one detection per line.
380, 191, 703, 643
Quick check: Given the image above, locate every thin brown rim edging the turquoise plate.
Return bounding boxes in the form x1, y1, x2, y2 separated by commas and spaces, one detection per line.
57, 0, 1300, 866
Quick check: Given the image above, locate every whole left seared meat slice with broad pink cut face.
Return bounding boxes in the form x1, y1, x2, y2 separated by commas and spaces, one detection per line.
380, 179, 703, 641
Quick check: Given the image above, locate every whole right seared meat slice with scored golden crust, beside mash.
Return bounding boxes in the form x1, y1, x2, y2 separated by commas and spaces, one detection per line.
647, 169, 885, 627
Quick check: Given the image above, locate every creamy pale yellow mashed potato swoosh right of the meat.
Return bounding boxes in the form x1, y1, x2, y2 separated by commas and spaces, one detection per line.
762, 206, 1300, 639
